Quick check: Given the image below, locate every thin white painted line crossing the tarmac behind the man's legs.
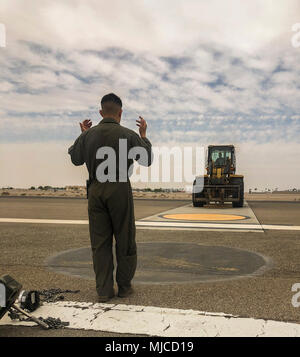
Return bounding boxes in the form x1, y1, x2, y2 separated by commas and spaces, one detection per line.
0, 218, 300, 231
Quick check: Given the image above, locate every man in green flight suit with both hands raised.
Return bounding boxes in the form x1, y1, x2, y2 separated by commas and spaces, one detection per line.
68, 93, 153, 302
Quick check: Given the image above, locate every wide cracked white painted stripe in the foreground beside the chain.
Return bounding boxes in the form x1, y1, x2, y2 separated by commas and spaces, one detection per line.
0, 302, 300, 337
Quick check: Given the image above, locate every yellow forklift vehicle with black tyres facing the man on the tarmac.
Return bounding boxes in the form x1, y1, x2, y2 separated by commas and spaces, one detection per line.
192, 145, 244, 207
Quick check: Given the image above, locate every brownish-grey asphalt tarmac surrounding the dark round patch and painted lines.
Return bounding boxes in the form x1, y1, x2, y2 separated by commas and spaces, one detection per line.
0, 197, 300, 336
